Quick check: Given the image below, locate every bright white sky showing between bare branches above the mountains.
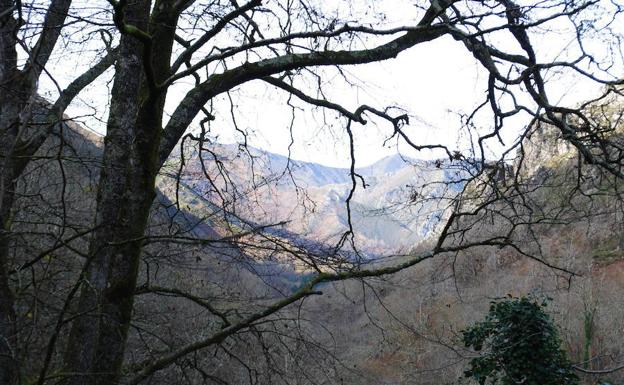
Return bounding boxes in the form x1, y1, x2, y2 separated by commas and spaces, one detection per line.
42, 1, 622, 167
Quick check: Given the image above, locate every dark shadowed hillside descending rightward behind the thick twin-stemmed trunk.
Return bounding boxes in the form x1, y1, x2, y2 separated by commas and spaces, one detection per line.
9, 122, 314, 384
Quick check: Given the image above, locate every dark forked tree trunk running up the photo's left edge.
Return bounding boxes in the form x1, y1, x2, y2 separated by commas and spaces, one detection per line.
0, 0, 71, 385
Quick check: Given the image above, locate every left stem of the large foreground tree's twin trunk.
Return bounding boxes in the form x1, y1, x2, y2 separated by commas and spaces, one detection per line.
65, 37, 149, 385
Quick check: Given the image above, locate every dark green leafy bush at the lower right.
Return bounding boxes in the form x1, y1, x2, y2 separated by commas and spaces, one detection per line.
462, 297, 578, 385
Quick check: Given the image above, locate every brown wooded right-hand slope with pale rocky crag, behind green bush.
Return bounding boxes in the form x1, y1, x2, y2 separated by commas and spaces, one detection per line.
298, 121, 624, 385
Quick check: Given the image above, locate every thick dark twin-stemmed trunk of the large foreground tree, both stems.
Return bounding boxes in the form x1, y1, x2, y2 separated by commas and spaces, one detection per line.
65, 1, 173, 385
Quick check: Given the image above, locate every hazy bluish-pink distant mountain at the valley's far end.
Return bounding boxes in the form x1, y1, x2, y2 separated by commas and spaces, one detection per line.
160, 144, 468, 257
